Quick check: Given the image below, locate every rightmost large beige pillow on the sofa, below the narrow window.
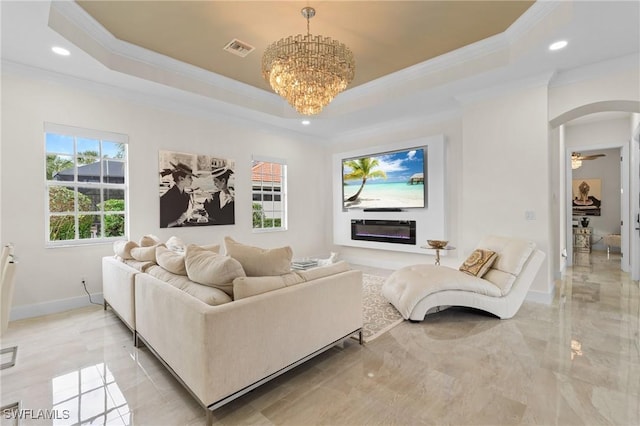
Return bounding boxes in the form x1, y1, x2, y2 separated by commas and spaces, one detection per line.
224, 237, 293, 277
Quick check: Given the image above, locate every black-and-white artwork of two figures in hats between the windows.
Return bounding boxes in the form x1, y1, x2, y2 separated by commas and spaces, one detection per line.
159, 151, 235, 228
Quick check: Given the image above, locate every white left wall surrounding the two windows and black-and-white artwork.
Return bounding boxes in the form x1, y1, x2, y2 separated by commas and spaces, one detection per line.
1, 72, 330, 318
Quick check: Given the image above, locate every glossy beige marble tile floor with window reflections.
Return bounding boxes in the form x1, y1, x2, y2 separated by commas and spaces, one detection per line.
0, 253, 640, 425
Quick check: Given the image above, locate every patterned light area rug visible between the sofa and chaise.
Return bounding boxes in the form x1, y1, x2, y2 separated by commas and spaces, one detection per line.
362, 274, 403, 342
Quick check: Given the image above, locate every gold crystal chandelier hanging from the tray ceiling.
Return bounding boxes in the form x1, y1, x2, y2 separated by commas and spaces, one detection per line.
262, 7, 355, 115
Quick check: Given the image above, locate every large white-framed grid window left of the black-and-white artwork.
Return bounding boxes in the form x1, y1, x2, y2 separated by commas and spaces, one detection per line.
45, 123, 128, 246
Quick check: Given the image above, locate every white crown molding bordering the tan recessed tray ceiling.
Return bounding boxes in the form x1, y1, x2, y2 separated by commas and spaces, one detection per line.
49, 1, 558, 123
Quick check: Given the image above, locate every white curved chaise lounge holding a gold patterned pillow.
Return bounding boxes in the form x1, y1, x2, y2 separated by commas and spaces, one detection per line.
382, 236, 545, 321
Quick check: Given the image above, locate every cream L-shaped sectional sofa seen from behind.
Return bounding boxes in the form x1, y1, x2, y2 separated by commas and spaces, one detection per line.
102, 236, 362, 422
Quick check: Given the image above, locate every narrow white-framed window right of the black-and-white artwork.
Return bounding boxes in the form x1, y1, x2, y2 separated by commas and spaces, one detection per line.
251, 156, 287, 231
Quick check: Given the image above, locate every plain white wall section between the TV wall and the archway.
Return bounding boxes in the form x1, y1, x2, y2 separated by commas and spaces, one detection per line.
461, 84, 553, 299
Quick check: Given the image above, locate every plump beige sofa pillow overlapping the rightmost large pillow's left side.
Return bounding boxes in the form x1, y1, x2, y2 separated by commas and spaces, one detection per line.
185, 244, 246, 296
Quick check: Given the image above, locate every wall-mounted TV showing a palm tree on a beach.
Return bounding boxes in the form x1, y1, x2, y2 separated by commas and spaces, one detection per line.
342, 148, 426, 209
